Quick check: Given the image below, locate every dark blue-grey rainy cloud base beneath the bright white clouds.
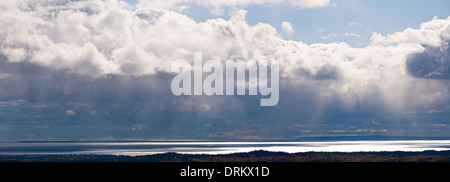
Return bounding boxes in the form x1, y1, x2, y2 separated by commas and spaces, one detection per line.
0, 53, 450, 140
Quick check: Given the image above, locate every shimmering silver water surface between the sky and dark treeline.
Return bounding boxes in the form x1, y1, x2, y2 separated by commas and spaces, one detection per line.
0, 140, 450, 156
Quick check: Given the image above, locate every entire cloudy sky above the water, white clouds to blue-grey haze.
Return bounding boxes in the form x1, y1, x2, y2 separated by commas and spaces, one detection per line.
0, 0, 450, 140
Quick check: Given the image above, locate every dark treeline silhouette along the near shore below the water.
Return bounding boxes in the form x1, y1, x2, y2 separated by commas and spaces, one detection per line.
0, 151, 450, 162
